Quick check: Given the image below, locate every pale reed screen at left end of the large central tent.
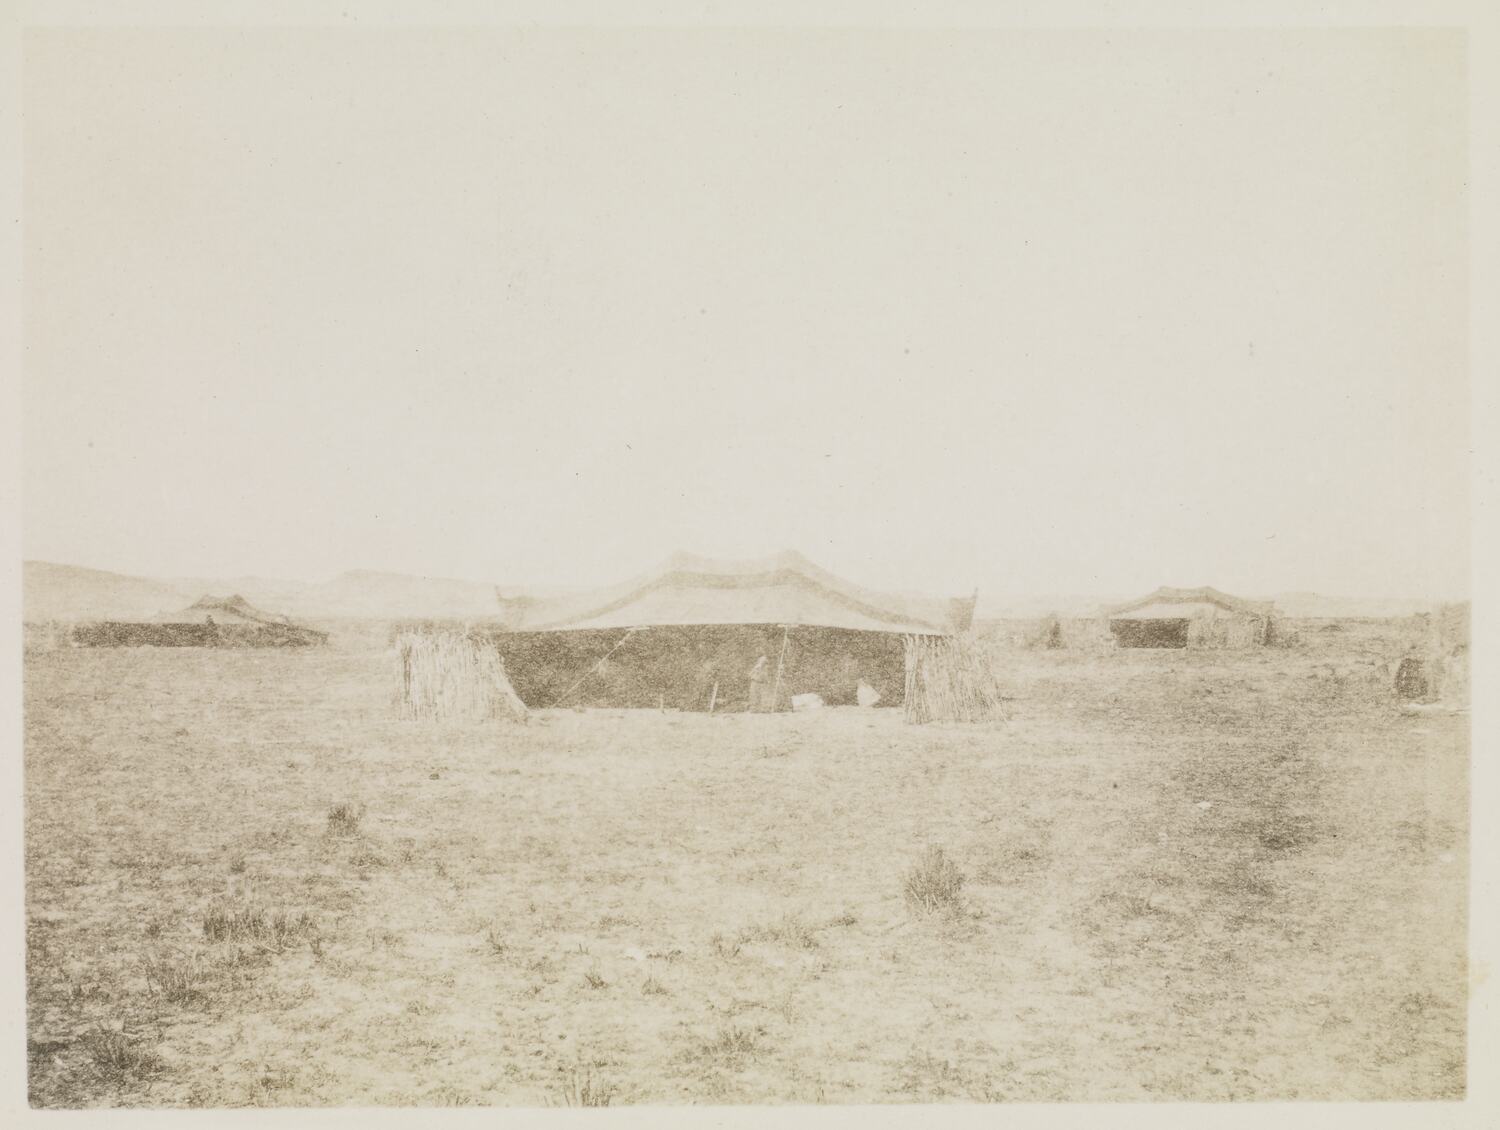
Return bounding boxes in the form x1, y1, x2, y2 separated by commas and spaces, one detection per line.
396, 632, 527, 722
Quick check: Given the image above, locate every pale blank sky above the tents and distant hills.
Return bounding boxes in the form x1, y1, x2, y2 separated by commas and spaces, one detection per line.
23, 30, 1470, 597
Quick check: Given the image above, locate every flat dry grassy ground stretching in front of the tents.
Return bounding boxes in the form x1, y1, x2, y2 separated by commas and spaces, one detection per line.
26, 632, 1469, 1106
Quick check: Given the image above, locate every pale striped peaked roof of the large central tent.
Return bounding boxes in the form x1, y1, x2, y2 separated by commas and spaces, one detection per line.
501, 551, 974, 635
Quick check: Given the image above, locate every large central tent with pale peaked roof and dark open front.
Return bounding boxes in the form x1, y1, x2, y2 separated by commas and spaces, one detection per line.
497, 552, 975, 710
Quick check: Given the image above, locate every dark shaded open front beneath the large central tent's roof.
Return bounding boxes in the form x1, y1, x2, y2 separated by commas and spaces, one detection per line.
491, 624, 906, 711
